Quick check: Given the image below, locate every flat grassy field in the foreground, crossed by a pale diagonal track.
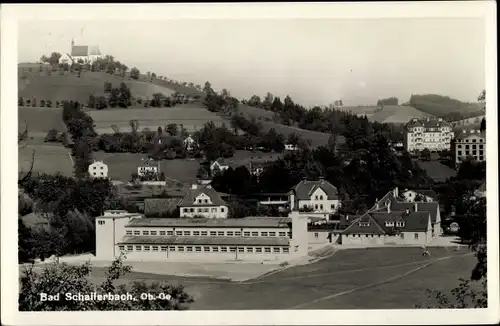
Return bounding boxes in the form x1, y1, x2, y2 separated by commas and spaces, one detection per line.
83, 248, 475, 310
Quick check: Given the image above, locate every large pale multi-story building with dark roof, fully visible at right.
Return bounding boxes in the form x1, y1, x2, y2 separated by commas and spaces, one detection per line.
403, 118, 453, 152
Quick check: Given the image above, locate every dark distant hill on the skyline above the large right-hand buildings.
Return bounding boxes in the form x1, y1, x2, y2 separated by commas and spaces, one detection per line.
408, 94, 484, 118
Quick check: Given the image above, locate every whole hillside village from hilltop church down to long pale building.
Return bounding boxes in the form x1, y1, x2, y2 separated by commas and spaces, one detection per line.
18, 42, 486, 310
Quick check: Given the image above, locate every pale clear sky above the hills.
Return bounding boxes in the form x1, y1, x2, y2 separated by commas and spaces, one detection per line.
18, 18, 485, 106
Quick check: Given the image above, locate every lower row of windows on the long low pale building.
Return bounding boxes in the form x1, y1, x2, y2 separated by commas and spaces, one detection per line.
118, 245, 290, 254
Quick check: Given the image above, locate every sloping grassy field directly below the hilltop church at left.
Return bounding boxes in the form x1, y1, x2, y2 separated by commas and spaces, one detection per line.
18, 71, 174, 104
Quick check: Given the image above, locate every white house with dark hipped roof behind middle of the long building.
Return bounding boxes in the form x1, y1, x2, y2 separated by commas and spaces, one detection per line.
177, 184, 229, 218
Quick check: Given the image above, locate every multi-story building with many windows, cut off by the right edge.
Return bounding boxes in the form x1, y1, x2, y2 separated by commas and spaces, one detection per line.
452, 129, 486, 167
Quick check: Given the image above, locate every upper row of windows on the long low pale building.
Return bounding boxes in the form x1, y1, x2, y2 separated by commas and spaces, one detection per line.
125, 229, 292, 237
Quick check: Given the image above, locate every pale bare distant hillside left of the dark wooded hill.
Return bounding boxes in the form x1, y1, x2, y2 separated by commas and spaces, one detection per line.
340, 105, 431, 124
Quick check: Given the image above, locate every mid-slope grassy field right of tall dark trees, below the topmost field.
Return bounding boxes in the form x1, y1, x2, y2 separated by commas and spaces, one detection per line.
88, 104, 224, 133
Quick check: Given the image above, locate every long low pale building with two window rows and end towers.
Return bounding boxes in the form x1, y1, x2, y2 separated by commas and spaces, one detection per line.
96, 212, 308, 262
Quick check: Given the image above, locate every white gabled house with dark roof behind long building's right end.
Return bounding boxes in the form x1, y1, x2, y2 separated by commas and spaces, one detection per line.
288, 178, 341, 219
